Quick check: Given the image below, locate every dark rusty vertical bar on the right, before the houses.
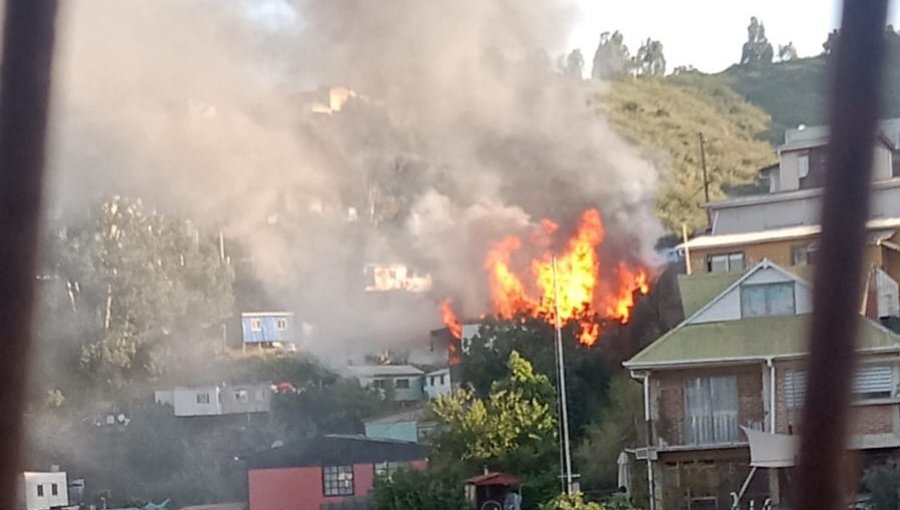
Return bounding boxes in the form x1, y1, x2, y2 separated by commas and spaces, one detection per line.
797, 0, 887, 510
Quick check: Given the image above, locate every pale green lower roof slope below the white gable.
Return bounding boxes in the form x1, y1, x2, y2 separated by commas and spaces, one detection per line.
625, 315, 900, 368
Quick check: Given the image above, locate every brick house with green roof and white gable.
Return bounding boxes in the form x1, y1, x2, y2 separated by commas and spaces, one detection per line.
624, 260, 900, 509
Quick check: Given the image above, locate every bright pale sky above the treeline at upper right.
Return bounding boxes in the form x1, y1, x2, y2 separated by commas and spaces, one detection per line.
569, 0, 900, 72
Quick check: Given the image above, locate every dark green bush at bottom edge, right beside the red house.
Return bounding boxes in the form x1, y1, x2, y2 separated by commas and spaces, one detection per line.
369, 469, 469, 510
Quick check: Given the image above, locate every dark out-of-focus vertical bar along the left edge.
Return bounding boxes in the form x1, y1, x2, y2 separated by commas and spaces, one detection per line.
0, 0, 56, 508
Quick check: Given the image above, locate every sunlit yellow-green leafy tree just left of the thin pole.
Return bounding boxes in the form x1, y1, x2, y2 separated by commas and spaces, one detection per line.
431, 351, 559, 505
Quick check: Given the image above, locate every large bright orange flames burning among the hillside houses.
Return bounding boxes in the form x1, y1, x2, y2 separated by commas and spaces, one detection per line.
441, 209, 650, 346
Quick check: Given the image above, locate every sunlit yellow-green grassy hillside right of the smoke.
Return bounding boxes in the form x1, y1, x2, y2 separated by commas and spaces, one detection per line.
594, 75, 775, 231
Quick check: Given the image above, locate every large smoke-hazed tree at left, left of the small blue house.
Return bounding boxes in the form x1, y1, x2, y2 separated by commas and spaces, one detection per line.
44, 197, 234, 386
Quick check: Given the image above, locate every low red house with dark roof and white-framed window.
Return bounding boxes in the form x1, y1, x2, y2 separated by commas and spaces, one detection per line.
247, 435, 427, 510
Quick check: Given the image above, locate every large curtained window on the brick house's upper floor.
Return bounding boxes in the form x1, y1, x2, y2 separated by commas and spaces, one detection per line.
684, 376, 738, 444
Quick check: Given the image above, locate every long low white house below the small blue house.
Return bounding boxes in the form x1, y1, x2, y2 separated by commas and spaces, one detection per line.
154, 383, 272, 416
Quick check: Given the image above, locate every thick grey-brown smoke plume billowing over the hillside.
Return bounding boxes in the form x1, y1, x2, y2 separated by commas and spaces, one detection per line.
50, 0, 660, 356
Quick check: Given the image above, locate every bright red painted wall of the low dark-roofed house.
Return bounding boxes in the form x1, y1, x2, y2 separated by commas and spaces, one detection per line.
247, 460, 428, 510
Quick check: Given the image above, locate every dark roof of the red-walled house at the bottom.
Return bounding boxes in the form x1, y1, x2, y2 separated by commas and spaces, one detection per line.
248, 435, 426, 469
